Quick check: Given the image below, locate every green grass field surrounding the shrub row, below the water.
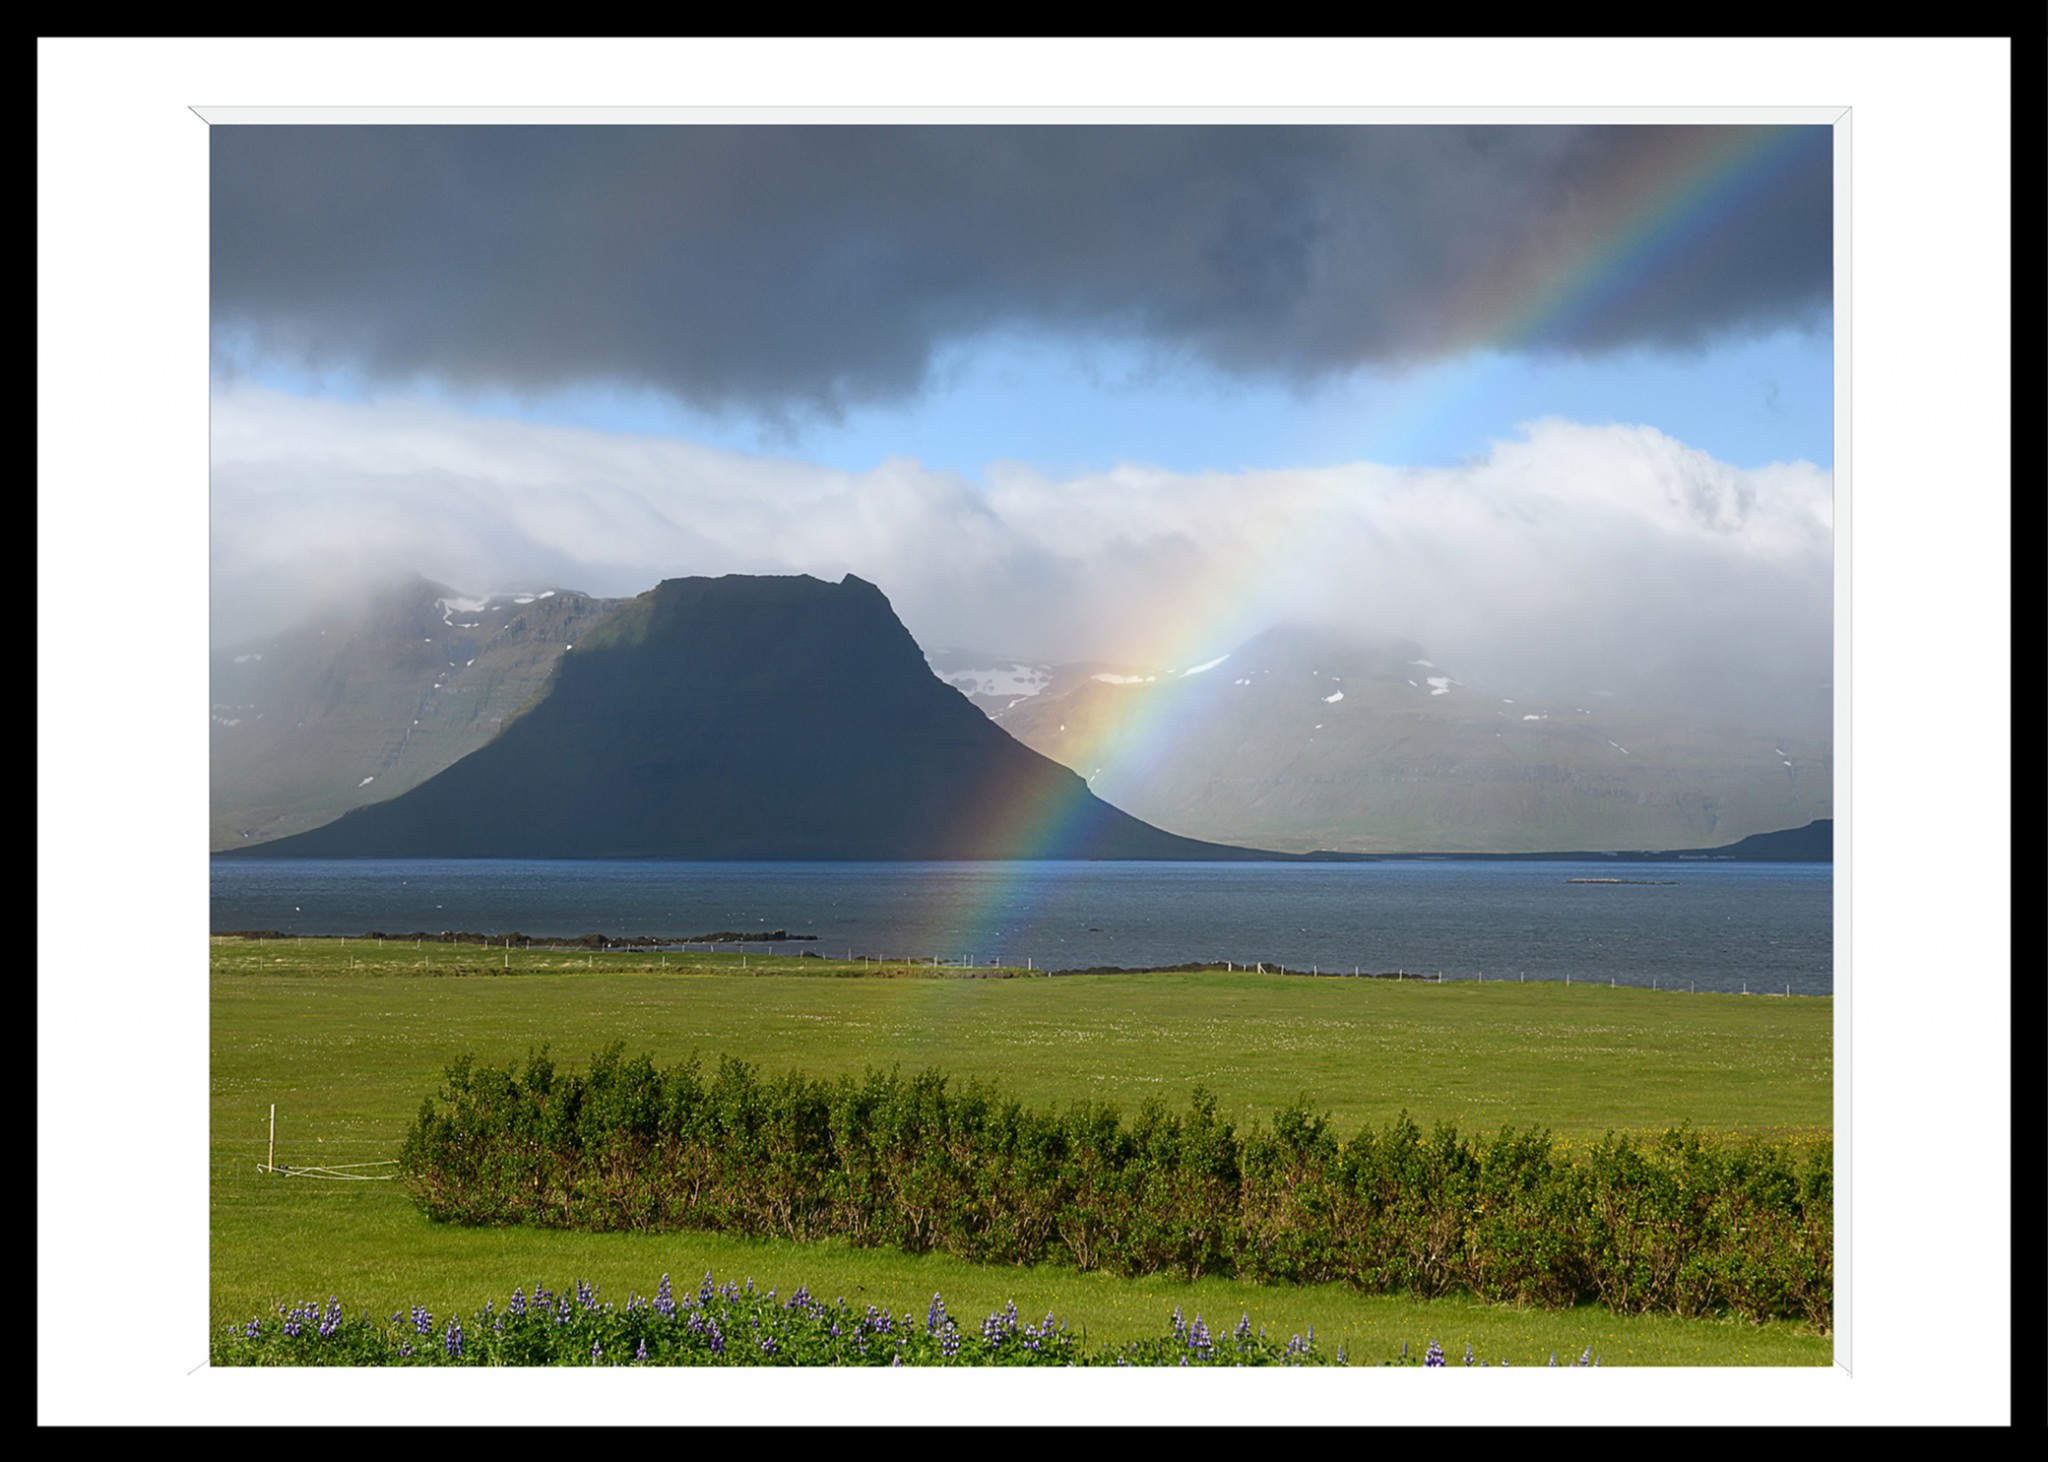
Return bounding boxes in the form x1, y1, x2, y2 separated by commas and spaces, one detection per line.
211, 940, 1833, 1366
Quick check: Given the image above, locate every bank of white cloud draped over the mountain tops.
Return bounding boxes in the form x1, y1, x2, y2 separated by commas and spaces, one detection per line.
213, 387, 1833, 716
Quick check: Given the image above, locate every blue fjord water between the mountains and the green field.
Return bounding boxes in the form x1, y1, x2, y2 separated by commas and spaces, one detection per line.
213, 860, 1835, 995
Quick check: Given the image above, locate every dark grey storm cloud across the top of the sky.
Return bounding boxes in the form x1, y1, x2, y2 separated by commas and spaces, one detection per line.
213, 125, 1833, 412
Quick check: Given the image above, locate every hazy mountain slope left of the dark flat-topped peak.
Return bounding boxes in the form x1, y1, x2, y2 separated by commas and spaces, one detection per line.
211, 575, 623, 850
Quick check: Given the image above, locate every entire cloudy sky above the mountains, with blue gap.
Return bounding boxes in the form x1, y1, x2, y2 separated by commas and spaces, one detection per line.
211, 125, 1835, 704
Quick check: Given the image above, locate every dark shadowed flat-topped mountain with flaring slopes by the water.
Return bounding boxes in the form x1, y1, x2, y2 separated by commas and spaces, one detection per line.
216, 575, 1257, 858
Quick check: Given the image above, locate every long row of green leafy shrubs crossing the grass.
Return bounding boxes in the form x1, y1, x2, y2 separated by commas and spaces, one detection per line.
399, 1042, 1833, 1333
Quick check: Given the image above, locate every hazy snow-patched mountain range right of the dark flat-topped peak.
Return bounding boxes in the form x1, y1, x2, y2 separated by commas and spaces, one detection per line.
966, 627, 1833, 854
